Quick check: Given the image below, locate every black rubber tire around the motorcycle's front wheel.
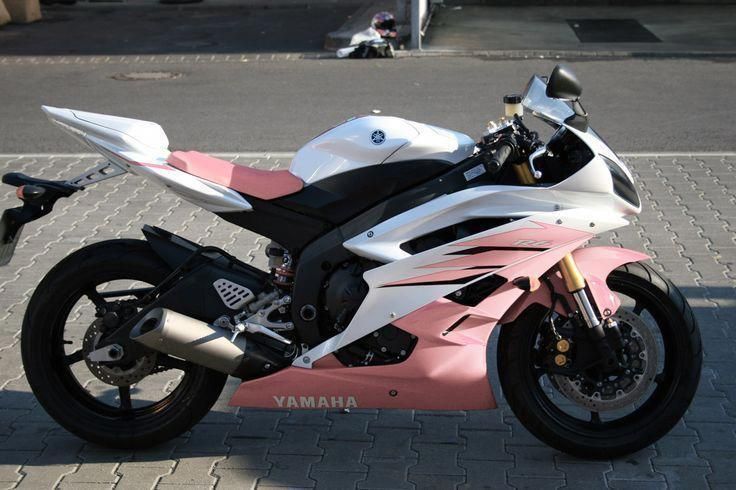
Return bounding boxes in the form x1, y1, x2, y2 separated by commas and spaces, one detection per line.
498, 263, 702, 459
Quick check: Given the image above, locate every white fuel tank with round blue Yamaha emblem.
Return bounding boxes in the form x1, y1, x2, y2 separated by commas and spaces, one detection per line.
290, 116, 475, 184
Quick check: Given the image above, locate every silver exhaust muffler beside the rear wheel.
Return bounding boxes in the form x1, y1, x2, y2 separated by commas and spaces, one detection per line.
130, 308, 292, 379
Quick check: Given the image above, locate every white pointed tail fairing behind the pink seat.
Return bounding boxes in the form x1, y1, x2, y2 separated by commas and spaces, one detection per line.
43, 106, 253, 212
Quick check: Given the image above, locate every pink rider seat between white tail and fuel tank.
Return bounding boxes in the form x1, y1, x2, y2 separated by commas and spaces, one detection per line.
166, 151, 304, 200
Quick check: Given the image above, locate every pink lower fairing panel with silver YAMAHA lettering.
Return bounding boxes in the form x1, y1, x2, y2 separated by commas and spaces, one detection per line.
230, 299, 496, 410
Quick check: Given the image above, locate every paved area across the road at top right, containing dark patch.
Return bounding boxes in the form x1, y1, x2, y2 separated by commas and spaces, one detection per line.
424, 5, 736, 57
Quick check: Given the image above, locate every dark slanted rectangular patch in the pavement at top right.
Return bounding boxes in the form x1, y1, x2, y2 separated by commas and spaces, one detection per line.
567, 19, 662, 43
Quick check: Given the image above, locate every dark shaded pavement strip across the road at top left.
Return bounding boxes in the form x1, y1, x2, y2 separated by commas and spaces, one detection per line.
0, 0, 358, 56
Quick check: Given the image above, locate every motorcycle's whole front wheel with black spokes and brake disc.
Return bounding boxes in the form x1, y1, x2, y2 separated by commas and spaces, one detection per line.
498, 263, 702, 458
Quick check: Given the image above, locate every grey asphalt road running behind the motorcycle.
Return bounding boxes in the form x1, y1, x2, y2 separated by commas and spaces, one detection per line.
0, 56, 736, 153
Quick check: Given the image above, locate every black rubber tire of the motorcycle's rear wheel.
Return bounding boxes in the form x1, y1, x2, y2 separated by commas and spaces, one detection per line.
21, 240, 227, 448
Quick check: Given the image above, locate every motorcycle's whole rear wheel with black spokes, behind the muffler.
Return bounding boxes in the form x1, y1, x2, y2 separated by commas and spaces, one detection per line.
21, 240, 227, 448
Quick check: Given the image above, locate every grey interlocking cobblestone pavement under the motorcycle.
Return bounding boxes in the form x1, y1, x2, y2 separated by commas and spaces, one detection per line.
0, 155, 736, 489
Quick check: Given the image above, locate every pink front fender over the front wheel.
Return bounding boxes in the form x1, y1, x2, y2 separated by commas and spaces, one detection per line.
499, 247, 650, 323
